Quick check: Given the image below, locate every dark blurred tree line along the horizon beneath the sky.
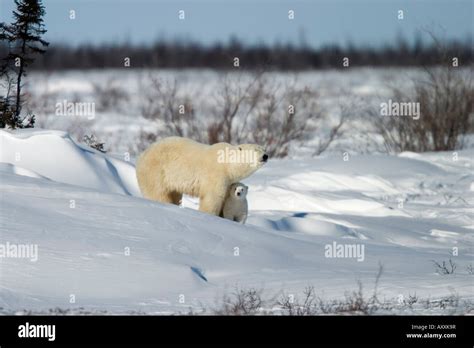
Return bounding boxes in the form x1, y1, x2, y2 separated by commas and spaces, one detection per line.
0, 35, 473, 70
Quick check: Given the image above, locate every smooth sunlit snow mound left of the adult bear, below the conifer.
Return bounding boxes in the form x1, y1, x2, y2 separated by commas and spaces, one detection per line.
0, 129, 140, 196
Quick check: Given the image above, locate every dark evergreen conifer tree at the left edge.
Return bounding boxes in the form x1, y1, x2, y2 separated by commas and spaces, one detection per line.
0, 0, 49, 128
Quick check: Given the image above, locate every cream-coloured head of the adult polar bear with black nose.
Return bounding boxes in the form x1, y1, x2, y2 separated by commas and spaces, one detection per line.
213, 143, 268, 182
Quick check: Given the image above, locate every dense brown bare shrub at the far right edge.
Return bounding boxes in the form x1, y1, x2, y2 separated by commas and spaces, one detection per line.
368, 35, 474, 153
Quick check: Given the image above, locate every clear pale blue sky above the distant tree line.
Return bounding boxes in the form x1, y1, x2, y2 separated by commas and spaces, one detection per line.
0, 0, 474, 47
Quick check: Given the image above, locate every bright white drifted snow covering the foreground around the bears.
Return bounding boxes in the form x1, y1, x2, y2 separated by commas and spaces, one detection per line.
0, 129, 474, 313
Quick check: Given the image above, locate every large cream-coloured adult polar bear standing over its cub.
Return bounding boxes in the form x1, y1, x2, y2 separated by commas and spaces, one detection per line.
136, 137, 268, 216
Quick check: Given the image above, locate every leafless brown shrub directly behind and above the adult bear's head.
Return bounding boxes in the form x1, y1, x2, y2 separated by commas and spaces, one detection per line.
207, 73, 324, 157
